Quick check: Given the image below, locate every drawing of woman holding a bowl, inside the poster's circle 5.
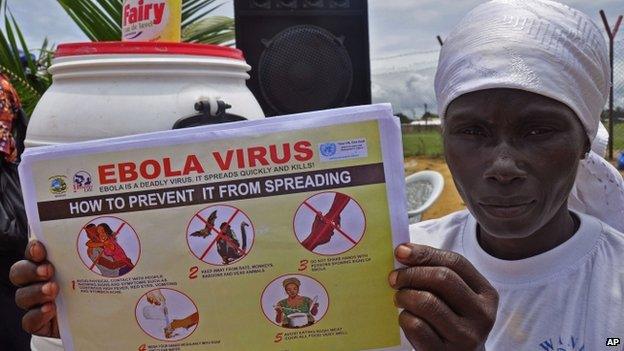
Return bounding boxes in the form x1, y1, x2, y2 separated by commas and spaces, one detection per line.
274, 278, 319, 328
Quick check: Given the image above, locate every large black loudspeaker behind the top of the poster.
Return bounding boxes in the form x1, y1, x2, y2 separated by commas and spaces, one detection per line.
234, 0, 371, 116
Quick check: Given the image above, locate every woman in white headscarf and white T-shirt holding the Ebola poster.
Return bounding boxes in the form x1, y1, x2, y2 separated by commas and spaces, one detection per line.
389, 0, 624, 350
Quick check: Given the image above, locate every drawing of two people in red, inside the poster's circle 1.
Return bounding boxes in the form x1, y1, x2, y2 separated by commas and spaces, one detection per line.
85, 223, 134, 278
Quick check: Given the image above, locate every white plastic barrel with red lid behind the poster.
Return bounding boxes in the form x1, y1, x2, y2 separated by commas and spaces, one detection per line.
25, 42, 264, 147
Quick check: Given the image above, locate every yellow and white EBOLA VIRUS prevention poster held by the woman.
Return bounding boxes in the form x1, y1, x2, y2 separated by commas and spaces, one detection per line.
20, 105, 410, 351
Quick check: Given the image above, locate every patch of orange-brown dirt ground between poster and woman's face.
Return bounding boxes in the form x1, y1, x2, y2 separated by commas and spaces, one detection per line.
404, 156, 465, 220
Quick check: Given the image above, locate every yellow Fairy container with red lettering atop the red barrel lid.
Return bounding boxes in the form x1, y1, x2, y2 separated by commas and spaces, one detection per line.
121, 0, 182, 42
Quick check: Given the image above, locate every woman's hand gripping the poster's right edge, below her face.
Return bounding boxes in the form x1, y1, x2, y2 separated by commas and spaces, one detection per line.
389, 244, 498, 351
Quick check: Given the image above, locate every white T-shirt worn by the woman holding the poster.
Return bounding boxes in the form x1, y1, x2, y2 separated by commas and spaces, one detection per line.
410, 211, 624, 351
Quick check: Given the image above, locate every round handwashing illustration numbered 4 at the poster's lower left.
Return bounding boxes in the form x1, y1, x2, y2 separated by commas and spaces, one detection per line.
137, 289, 199, 341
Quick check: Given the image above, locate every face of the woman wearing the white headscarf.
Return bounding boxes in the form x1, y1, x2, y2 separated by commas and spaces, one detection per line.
444, 89, 589, 239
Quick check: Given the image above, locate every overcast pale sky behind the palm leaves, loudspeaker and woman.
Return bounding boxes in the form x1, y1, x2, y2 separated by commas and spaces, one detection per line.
8, 0, 624, 115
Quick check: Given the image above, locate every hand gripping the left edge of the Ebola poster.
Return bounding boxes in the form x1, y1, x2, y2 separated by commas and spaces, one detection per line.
9, 240, 60, 338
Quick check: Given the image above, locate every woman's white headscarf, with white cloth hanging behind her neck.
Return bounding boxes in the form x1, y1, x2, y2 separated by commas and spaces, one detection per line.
435, 0, 624, 231
